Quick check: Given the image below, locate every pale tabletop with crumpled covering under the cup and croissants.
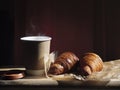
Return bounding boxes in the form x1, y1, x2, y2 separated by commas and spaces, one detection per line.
0, 59, 120, 90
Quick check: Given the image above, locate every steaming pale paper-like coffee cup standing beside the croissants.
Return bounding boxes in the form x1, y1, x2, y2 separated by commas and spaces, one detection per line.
20, 36, 52, 76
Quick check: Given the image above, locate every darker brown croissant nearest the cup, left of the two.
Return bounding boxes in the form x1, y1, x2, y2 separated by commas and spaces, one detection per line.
48, 52, 79, 75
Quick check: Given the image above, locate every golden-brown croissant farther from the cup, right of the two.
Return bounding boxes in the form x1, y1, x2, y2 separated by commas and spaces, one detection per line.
79, 53, 103, 75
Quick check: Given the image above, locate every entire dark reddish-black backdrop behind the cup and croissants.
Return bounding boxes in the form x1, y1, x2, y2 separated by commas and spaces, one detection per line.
0, 0, 120, 66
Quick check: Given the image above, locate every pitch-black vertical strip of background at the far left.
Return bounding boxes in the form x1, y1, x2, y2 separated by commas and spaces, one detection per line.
0, 0, 15, 66
